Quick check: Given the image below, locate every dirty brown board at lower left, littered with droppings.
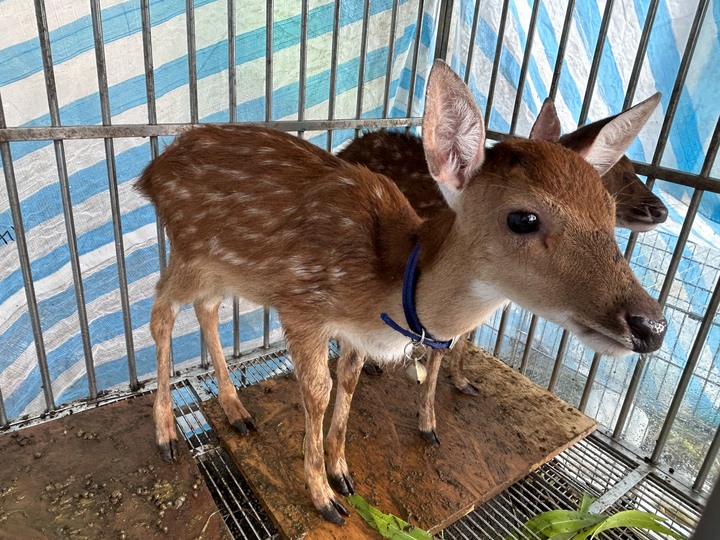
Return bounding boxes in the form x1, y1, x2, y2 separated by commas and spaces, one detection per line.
0, 394, 231, 540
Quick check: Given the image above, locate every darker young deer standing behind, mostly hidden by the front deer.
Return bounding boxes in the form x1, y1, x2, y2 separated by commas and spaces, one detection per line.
337, 97, 667, 395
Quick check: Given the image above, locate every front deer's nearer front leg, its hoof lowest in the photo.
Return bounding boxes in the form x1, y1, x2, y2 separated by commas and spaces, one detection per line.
280, 322, 350, 525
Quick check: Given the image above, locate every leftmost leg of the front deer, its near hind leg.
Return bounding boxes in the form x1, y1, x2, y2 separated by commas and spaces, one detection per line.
150, 294, 180, 461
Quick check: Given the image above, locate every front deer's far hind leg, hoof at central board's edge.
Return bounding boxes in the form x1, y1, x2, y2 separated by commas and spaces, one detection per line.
194, 297, 257, 435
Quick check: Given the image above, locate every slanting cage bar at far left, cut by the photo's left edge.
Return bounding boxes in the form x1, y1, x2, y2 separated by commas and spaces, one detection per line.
0, 96, 55, 411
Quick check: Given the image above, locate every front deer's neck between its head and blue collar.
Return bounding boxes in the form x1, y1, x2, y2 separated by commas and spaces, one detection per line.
396, 210, 507, 339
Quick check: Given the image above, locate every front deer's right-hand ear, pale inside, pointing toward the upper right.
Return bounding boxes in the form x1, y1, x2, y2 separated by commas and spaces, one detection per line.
574, 92, 660, 176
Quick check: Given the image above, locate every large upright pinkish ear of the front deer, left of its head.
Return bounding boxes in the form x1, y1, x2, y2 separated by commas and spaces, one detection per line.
423, 60, 485, 207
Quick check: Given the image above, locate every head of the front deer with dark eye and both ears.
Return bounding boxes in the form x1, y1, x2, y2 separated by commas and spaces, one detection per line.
423, 61, 666, 354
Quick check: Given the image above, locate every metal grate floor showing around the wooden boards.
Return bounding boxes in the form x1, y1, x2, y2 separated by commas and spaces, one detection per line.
165, 345, 703, 540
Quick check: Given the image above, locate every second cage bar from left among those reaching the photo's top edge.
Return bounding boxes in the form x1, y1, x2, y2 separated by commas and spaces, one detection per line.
90, 0, 139, 390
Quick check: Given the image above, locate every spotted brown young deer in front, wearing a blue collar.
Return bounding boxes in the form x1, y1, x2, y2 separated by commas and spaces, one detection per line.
138, 61, 665, 523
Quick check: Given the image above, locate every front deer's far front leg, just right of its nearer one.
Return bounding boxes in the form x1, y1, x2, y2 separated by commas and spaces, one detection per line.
327, 344, 365, 496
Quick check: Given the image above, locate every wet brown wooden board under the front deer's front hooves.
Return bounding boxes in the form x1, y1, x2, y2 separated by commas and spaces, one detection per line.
203, 347, 595, 540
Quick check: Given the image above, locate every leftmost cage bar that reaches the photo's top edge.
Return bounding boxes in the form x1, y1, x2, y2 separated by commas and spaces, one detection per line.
35, 0, 97, 399
